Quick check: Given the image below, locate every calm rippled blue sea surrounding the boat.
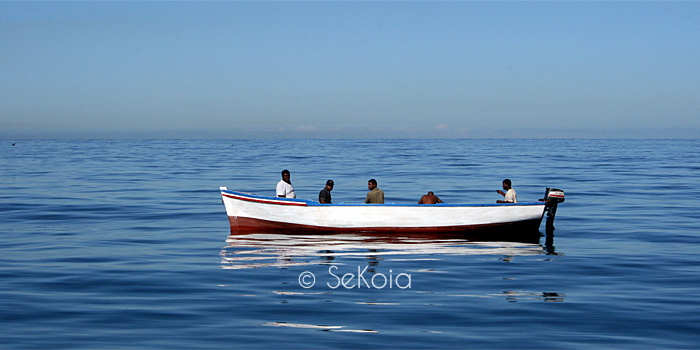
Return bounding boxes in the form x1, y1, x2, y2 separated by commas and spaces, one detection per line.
0, 140, 700, 349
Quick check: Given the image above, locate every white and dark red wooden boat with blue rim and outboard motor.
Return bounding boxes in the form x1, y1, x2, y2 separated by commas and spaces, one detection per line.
219, 187, 564, 242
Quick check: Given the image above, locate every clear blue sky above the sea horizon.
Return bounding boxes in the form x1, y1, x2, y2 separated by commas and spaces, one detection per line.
0, 1, 700, 139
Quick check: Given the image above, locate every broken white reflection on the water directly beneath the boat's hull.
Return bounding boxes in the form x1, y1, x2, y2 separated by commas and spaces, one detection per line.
221, 233, 549, 269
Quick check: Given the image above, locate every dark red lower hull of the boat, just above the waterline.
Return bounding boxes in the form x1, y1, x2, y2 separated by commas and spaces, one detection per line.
228, 217, 542, 243
